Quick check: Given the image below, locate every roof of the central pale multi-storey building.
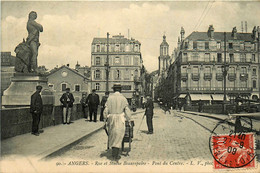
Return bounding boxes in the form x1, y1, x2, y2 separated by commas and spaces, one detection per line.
92, 36, 141, 44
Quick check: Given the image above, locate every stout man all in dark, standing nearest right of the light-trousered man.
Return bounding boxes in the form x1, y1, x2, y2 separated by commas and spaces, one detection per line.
87, 89, 99, 122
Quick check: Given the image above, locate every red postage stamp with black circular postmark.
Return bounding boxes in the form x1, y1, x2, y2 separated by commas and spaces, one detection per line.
211, 133, 256, 169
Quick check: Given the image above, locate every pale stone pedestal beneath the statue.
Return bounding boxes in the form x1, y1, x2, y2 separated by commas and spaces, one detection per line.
2, 73, 54, 108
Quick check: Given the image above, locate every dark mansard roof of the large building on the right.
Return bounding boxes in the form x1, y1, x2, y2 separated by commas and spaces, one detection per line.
185, 31, 253, 41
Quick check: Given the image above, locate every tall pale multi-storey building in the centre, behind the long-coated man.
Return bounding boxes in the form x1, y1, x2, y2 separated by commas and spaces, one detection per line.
91, 34, 143, 102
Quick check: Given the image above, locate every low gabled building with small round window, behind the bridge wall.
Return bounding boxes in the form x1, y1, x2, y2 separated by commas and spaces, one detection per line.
46, 65, 90, 105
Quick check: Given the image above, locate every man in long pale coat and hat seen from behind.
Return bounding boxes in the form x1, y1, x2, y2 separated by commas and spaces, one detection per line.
104, 84, 131, 160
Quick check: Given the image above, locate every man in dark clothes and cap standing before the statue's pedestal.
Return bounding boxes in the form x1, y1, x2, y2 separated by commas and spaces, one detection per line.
30, 86, 43, 136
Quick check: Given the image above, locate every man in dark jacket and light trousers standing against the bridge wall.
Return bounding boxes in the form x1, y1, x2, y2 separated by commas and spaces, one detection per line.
60, 88, 75, 125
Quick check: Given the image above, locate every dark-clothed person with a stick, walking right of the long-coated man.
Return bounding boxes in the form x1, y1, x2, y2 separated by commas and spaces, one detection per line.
144, 96, 154, 134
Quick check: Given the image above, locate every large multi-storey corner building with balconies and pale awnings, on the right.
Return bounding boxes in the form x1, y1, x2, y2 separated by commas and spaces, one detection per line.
172, 25, 260, 104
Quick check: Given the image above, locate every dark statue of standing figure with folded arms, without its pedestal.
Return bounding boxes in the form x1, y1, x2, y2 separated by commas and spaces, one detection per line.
15, 11, 43, 73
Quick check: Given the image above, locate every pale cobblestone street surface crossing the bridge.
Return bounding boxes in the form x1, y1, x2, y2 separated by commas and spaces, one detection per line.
53, 107, 225, 161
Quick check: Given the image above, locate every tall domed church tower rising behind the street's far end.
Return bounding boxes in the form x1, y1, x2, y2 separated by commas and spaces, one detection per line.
158, 35, 170, 76
